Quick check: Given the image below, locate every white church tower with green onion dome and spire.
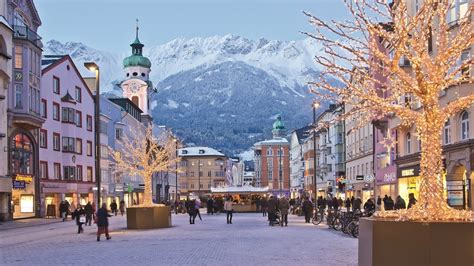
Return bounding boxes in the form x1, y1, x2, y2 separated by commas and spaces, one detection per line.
120, 19, 154, 124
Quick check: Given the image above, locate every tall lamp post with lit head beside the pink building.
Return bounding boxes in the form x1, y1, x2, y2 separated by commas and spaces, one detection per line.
84, 62, 101, 210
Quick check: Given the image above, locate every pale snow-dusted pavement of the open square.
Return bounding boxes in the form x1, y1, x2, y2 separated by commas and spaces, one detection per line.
0, 213, 358, 265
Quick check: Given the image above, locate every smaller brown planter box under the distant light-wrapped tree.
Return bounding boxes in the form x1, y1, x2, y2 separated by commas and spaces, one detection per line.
127, 206, 171, 229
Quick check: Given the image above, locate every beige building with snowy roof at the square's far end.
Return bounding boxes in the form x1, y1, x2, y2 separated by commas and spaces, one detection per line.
178, 147, 228, 199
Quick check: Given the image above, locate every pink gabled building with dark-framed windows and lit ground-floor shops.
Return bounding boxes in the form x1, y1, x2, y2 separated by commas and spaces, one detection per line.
39, 55, 95, 216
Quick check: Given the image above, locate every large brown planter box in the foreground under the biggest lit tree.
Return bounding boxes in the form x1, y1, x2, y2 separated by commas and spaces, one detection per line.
359, 218, 474, 266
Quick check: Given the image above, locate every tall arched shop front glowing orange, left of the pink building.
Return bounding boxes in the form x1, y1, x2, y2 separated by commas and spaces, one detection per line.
9, 131, 39, 219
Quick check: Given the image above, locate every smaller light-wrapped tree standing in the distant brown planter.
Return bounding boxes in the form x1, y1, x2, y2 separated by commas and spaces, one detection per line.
112, 126, 179, 206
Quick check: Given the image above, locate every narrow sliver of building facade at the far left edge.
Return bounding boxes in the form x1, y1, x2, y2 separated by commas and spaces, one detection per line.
0, 1, 13, 222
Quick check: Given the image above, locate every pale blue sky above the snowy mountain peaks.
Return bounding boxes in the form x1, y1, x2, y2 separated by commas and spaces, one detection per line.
35, 0, 346, 52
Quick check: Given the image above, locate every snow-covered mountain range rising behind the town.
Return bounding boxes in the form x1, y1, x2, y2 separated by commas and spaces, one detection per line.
43, 35, 326, 153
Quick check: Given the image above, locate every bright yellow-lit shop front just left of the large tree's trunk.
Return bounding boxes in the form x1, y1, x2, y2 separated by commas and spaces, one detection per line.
398, 164, 420, 202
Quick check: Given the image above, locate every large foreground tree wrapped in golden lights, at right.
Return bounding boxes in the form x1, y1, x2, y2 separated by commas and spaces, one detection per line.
305, 0, 474, 220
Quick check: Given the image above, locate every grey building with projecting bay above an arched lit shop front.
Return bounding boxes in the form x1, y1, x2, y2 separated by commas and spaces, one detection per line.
6, 0, 44, 219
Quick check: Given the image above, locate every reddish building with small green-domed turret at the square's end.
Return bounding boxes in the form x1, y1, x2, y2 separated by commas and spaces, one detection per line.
254, 116, 290, 197
